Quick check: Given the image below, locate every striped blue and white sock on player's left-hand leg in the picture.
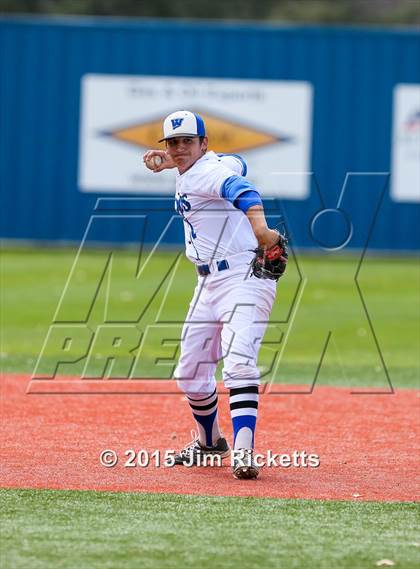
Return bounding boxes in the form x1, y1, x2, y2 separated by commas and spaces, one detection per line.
187, 389, 221, 447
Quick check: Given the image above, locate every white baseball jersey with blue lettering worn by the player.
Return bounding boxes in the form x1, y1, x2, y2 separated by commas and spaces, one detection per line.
175, 151, 258, 264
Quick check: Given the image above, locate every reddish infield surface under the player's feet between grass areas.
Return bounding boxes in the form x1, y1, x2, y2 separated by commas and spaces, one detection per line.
1, 375, 419, 501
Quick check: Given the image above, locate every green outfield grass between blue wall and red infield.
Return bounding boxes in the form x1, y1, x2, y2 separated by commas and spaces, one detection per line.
1, 249, 420, 388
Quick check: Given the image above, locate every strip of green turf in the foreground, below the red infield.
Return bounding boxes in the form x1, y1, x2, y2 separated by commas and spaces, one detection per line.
0, 490, 420, 569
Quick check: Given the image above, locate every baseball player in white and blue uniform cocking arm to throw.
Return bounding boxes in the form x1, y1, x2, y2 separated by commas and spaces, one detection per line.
143, 111, 287, 479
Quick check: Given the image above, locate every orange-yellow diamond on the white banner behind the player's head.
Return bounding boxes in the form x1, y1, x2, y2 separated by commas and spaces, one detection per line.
107, 112, 291, 153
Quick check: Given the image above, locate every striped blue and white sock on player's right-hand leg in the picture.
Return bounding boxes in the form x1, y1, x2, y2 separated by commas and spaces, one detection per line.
229, 385, 259, 450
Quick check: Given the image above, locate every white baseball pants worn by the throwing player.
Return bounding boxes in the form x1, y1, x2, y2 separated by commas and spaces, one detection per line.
175, 255, 276, 394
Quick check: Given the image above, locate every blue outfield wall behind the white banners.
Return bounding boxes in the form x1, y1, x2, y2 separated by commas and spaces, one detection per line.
0, 17, 420, 250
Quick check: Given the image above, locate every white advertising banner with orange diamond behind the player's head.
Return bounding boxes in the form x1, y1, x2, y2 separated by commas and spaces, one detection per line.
78, 74, 312, 199
